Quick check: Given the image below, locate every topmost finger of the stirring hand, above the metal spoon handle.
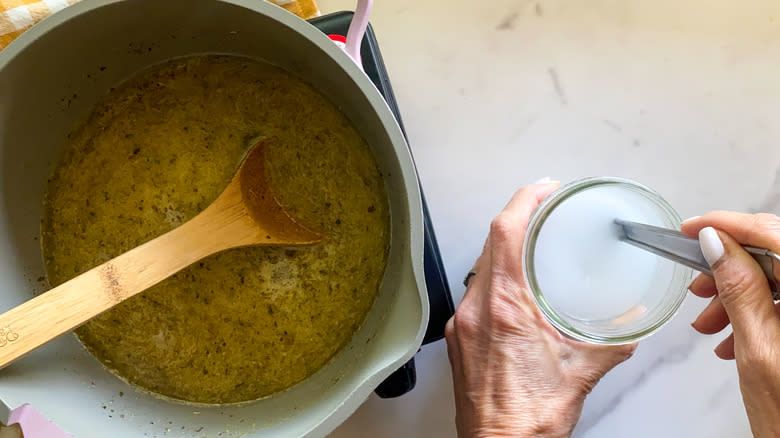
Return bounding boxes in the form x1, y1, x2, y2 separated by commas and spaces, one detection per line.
681, 211, 780, 252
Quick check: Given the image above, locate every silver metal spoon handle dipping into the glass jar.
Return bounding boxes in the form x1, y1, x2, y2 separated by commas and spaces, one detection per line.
615, 219, 780, 301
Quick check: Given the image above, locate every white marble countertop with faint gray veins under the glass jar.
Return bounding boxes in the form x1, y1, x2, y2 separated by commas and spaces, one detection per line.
319, 0, 780, 438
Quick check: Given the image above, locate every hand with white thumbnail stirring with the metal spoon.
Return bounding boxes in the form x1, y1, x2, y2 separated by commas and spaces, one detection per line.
682, 211, 780, 437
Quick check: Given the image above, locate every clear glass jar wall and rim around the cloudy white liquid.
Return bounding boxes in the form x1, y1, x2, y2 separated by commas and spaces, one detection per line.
523, 177, 692, 345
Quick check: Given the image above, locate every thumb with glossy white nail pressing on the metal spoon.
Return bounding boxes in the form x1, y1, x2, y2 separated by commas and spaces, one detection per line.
699, 227, 777, 339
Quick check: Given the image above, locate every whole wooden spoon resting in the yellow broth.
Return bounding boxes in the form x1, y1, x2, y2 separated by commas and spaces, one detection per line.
0, 141, 323, 368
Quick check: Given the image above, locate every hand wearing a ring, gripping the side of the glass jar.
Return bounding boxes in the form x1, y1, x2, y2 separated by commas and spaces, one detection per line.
445, 183, 636, 437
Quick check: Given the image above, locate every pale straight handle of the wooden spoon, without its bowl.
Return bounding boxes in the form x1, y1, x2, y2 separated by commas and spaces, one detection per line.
0, 212, 235, 368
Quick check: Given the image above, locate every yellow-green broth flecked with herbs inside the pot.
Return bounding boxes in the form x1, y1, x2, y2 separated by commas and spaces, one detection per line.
43, 56, 390, 403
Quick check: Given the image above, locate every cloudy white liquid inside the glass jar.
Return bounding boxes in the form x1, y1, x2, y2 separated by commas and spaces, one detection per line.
534, 185, 673, 326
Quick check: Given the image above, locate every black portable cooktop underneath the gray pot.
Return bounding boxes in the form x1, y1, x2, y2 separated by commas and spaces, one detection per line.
309, 12, 455, 398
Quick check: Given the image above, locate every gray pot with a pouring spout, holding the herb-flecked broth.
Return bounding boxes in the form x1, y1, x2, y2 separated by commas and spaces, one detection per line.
0, 0, 428, 438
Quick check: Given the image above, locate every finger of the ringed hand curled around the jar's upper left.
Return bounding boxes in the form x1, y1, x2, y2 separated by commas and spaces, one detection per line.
490, 182, 560, 282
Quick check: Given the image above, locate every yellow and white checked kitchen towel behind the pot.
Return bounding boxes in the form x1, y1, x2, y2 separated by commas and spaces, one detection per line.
0, 0, 319, 50
